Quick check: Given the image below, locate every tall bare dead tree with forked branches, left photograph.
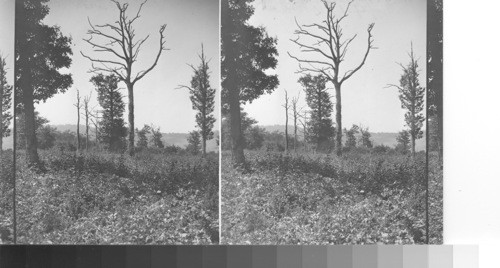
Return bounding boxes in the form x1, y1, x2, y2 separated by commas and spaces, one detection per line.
80, 0, 167, 156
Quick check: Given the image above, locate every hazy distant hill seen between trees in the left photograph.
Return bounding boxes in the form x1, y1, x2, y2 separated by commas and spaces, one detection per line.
3, 124, 219, 151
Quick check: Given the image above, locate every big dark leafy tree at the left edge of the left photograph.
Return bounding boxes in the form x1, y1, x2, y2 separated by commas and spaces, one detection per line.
15, 0, 73, 165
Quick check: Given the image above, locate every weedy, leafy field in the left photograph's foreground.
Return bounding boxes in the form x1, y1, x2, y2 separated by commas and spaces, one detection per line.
2, 150, 219, 244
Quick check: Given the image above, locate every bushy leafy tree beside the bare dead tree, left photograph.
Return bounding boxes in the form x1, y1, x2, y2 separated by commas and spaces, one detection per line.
90, 74, 127, 151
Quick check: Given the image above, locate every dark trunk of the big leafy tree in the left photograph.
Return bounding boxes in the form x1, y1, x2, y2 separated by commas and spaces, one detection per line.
23, 89, 39, 166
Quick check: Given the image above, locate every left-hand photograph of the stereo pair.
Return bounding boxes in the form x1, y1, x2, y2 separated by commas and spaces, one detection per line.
7, 0, 220, 245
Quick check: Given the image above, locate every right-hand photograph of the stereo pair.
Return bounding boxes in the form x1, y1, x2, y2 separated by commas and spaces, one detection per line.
221, 0, 443, 245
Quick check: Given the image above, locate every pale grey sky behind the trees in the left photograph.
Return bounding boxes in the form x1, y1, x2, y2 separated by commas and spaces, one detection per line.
35, 0, 220, 133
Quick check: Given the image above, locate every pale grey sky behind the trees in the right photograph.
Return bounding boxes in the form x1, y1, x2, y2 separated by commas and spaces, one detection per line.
245, 0, 426, 132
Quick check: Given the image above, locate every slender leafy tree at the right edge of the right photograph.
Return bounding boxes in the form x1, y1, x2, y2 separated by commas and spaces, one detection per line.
389, 45, 425, 157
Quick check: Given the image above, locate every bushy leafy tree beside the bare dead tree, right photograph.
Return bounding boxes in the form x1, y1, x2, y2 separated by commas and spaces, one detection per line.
299, 74, 335, 151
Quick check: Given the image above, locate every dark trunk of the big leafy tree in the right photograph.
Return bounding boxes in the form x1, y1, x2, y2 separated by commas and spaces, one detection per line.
229, 86, 245, 166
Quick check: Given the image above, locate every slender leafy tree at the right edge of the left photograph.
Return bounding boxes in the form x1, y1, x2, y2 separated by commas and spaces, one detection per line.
180, 44, 215, 155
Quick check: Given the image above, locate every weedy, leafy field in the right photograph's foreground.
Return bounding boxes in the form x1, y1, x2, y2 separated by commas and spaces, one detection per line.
221, 151, 442, 244
